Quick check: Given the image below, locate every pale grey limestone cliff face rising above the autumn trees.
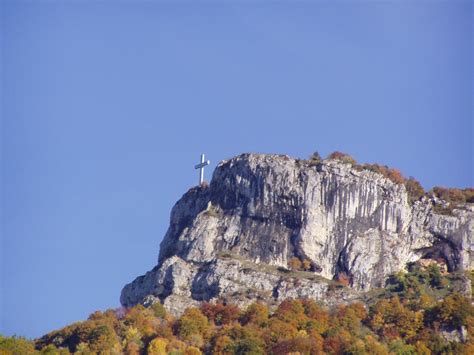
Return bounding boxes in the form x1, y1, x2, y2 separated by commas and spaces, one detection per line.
121, 154, 474, 313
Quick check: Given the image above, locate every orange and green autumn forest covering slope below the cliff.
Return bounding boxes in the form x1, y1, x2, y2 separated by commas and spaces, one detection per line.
4, 263, 474, 355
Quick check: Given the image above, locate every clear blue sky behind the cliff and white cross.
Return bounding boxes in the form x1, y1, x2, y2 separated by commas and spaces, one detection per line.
0, 1, 474, 337
